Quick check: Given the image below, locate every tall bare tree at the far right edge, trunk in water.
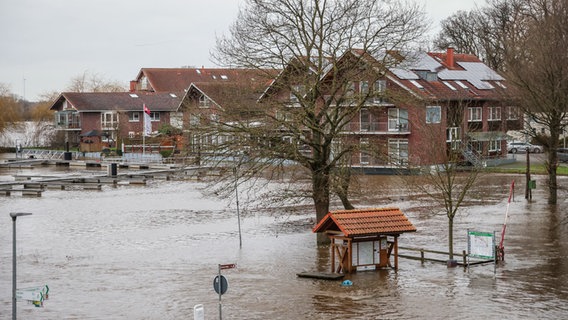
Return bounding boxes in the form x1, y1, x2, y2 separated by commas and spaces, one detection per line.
505, 0, 568, 204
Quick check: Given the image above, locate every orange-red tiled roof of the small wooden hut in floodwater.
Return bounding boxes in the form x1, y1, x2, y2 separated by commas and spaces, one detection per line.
312, 208, 416, 237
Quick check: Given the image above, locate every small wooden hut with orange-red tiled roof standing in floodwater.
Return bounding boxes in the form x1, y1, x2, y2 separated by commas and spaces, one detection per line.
313, 208, 416, 273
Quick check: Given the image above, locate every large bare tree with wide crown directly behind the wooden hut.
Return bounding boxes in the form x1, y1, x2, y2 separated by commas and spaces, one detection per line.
209, 0, 425, 239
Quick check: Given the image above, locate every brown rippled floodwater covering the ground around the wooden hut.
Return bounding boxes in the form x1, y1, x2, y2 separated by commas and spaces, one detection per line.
0, 159, 568, 319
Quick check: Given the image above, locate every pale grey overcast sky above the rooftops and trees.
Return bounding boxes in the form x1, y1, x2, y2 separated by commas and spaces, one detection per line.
0, 0, 485, 101
